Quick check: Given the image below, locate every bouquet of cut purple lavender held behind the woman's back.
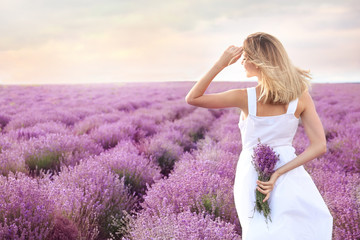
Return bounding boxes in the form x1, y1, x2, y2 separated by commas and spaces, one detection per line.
252, 139, 279, 223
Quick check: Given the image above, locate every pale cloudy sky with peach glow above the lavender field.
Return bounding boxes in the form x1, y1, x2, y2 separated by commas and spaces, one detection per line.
0, 0, 360, 84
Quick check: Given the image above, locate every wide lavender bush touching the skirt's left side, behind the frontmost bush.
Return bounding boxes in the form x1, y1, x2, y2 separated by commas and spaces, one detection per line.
142, 163, 236, 221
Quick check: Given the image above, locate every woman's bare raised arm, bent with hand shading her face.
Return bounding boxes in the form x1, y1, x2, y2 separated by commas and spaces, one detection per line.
185, 46, 246, 108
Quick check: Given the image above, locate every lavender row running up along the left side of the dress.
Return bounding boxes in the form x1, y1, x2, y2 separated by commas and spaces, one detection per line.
127, 111, 241, 239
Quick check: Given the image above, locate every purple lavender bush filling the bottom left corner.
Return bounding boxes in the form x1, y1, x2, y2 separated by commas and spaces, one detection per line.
0, 173, 55, 239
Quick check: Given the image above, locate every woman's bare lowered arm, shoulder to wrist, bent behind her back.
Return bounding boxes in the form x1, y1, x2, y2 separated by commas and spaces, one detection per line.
275, 91, 326, 176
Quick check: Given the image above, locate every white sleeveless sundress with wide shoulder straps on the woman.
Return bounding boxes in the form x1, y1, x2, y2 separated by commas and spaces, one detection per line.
234, 87, 333, 240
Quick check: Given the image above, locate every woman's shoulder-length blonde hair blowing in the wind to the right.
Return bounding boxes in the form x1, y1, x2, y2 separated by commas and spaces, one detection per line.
243, 32, 311, 104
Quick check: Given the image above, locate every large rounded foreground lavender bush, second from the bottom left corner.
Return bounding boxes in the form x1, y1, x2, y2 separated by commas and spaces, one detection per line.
48, 159, 136, 239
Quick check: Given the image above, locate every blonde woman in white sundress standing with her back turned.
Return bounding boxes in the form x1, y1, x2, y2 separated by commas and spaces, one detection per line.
186, 32, 333, 240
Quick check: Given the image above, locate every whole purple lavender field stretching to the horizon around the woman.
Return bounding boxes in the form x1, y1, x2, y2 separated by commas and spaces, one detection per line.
0, 82, 360, 240
